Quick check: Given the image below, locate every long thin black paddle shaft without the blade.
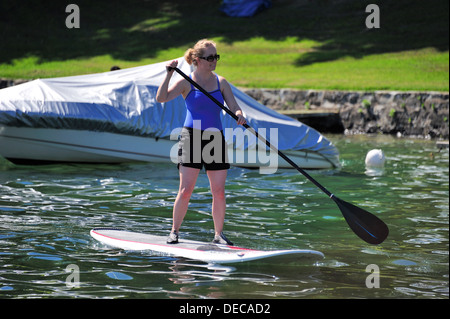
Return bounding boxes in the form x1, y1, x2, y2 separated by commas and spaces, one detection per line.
168, 67, 333, 198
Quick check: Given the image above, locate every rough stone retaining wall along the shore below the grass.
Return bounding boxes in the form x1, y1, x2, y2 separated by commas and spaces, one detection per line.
0, 79, 449, 140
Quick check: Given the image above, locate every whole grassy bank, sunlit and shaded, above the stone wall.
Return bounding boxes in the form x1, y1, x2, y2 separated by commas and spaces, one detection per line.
0, 0, 449, 91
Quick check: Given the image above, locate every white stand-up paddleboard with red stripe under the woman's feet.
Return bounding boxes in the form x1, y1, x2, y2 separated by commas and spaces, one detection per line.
91, 228, 324, 263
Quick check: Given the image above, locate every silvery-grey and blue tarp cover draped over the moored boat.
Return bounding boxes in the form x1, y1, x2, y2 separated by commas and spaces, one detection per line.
0, 58, 339, 167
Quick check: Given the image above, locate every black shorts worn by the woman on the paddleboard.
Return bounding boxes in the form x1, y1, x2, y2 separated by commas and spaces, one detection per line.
178, 127, 230, 171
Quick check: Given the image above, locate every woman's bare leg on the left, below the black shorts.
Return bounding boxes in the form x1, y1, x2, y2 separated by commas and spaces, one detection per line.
172, 165, 200, 232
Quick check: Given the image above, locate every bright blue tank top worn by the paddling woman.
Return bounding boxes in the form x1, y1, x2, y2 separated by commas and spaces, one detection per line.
184, 75, 224, 130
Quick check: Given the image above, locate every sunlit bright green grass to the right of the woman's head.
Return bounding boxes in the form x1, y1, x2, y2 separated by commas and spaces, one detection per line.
218, 39, 449, 91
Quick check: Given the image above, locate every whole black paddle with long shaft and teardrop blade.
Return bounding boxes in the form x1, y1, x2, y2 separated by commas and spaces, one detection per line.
168, 67, 389, 245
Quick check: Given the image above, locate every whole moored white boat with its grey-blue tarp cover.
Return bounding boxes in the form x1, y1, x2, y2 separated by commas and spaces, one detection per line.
0, 58, 339, 169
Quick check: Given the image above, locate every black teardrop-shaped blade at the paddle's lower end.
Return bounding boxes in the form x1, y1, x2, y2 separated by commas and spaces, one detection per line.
332, 196, 389, 245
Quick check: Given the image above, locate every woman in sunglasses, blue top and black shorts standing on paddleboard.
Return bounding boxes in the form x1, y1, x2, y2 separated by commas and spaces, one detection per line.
156, 39, 246, 245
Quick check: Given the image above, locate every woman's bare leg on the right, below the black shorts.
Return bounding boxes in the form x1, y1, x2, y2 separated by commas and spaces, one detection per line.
207, 170, 227, 235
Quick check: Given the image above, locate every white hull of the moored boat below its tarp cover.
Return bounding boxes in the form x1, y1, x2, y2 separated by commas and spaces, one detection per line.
0, 125, 335, 169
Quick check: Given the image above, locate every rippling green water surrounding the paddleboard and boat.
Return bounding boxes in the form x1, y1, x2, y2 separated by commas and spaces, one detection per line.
0, 136, 449, 299
